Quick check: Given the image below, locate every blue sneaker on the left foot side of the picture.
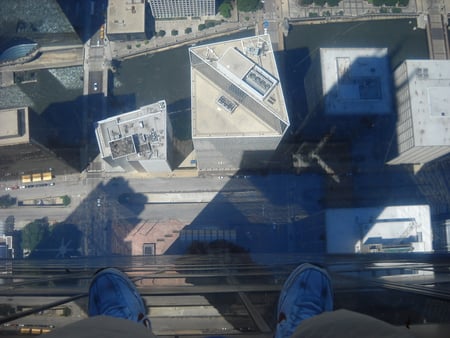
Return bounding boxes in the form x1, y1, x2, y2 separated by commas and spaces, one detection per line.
88, 268, 151, 329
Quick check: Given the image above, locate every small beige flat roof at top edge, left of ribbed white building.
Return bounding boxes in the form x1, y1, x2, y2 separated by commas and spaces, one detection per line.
106, 0, 146, 34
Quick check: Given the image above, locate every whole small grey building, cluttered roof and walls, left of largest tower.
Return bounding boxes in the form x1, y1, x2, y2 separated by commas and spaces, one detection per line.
95, 100, 172, 173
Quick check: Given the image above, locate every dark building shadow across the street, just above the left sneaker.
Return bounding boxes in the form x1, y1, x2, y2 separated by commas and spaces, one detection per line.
22, 178, 146, 259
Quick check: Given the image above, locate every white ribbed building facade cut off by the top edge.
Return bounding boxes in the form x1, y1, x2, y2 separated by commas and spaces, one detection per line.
149, 0, 216, 19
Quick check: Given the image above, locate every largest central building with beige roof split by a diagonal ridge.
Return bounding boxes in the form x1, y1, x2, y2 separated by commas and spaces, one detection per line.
189, 35, 289, 171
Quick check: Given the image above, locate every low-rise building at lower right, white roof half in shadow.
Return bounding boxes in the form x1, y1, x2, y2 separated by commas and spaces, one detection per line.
297, 205, 434, 254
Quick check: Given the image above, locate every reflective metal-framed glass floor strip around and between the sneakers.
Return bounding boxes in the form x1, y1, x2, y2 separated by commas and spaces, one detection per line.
0, 253, 450, 337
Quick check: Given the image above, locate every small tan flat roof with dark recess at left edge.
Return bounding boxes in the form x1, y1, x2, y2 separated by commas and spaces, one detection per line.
0, 107, 30, 146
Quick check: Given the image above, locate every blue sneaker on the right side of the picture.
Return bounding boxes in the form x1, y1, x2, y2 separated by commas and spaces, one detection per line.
275, 263, 333, 338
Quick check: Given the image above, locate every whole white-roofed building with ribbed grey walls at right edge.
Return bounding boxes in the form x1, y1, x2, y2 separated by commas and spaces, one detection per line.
388, 60, 450, 164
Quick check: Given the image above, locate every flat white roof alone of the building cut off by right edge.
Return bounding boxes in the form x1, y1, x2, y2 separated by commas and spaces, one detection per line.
405, 60, 450, 146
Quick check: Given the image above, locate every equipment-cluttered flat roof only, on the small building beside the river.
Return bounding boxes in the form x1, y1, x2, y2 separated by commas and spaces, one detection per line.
96, 101, 167, 161
